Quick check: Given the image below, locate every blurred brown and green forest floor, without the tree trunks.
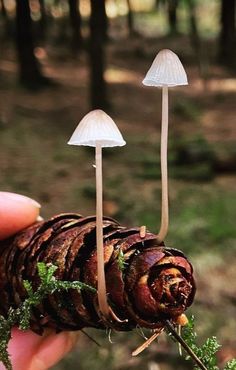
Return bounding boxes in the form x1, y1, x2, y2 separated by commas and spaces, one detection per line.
0, 31, 236, 370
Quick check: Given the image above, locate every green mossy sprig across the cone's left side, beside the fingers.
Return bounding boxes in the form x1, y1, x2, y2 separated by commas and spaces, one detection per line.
0, 262, 97, 370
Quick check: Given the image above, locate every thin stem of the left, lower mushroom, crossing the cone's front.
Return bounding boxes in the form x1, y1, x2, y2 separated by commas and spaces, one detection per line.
95, 144, 109, 317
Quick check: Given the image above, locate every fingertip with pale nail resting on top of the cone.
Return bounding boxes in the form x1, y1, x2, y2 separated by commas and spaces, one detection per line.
0, 192, 40, 239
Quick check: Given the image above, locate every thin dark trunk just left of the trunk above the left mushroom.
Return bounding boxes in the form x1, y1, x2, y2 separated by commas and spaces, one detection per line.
68, 0, 83, 54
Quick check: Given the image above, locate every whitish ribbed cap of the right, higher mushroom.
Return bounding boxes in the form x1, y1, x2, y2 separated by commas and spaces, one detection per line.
143, 49, 188, 86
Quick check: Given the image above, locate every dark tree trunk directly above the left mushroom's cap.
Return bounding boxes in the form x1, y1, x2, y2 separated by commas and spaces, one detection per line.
89, 0, 108, 109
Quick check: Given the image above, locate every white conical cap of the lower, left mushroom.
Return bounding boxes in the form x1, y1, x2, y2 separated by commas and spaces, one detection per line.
68, 109, 126, 147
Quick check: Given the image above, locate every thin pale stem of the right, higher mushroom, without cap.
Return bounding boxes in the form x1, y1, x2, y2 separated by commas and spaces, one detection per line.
157, 86, 169, 242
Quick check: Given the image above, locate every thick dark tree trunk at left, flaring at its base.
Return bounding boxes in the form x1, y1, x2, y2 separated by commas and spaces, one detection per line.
16, 0, 45, 87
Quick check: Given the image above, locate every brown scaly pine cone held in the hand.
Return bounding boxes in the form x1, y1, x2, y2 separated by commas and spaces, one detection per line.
0, 214, 195, 334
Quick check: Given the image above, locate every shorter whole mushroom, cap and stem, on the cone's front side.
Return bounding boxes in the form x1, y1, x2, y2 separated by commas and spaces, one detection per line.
68, 109, 126, 319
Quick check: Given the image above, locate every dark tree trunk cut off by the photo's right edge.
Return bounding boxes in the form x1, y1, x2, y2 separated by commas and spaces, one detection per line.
219, 0, 236, 66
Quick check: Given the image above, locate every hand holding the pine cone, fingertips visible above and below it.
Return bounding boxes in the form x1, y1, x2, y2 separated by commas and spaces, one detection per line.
0, 192, 78, 370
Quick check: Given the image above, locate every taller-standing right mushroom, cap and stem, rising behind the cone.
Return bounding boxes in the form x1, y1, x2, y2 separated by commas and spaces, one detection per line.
143, 49, 188, 242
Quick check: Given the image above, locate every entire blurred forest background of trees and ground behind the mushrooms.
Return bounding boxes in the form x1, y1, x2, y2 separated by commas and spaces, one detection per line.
0, 0, 236, 370
